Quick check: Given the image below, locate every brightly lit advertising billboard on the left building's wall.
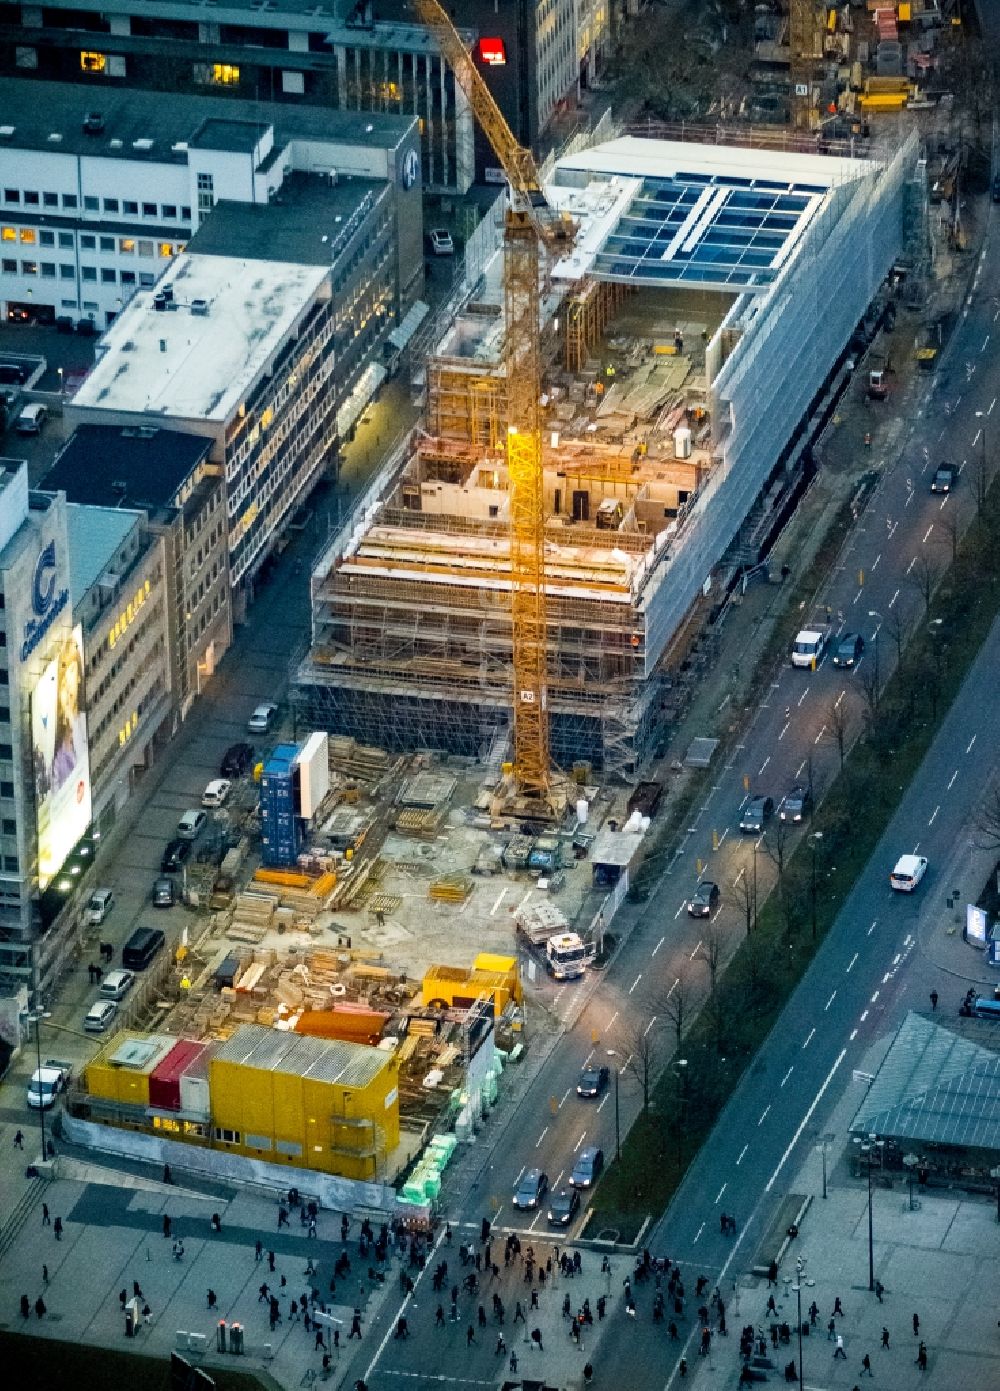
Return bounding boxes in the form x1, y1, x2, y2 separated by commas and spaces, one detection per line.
31, 625, 90, 890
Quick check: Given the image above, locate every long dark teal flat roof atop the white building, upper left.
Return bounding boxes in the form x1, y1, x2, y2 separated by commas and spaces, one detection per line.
0, 77, 416, 164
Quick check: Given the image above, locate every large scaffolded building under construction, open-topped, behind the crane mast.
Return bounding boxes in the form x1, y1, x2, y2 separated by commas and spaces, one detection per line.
298, 131, 917, 779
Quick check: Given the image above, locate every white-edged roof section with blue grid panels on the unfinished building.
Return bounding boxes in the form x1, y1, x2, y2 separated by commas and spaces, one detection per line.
545, 135, 873, 292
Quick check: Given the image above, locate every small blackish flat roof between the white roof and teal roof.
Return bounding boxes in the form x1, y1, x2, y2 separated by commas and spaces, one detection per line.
43, 424, 211, 512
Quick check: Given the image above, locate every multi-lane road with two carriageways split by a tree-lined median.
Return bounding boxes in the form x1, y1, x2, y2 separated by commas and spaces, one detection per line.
371, 208, 1000, 1378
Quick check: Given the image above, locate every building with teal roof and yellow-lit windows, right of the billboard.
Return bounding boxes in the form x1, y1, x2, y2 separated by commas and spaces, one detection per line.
67, 502, 174, 835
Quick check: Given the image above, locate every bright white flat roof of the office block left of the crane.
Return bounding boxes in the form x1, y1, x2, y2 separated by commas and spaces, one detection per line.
72, 252, 328, 423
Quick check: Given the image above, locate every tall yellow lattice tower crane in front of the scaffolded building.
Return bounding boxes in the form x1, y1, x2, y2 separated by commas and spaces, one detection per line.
414, 0, 574, 811
